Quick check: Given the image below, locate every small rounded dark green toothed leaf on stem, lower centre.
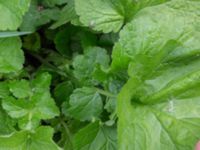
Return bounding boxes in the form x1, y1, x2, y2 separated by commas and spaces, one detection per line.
67, 87, 103, 121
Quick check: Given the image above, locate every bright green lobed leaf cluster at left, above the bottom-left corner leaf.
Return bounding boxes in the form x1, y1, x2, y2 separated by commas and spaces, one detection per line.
2, 73, 59, 130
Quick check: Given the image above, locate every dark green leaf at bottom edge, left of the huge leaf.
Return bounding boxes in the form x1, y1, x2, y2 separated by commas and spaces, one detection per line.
73, 122, 117, 150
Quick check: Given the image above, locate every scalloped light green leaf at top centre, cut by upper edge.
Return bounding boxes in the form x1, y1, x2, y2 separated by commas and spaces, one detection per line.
75, 0, 168, 33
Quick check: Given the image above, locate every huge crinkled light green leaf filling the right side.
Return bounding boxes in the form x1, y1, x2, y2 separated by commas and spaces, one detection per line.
116, 0, 200, 150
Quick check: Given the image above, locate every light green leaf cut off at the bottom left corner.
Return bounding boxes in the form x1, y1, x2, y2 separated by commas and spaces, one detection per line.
0, 127, 61, 150
